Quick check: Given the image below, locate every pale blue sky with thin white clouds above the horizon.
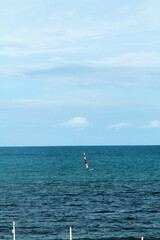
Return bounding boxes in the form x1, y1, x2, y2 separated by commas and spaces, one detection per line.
0, 0, 160, 146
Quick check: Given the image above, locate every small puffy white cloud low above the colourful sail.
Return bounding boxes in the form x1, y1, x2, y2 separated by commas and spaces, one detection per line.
62, 117, 90, 129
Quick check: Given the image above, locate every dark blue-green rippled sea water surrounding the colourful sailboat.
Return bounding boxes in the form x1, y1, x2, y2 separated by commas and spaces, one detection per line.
0, 146, 160, 240
